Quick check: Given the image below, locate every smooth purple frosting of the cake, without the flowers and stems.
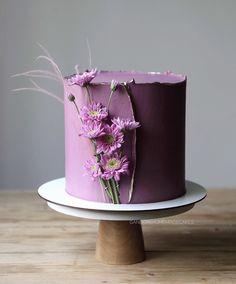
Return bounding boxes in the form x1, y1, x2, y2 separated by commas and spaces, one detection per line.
65, 71, 186, 203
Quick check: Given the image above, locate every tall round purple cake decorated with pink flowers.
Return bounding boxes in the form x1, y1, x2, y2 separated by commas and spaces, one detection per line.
64, 70, 186, 203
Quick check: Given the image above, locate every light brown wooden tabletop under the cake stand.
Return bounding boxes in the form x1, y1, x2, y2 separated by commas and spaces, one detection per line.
0, 189, 236, 284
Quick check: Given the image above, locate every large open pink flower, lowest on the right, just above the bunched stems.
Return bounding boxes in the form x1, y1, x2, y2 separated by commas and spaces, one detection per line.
100, 153, 129, 181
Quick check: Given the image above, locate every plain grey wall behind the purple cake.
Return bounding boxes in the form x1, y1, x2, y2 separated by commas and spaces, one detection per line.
0, 0, 236, 189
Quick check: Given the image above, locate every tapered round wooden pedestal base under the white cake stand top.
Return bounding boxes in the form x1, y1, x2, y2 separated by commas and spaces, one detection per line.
96, 221, 145, 264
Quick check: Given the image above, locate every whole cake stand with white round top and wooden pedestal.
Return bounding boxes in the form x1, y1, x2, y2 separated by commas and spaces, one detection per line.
38, 178, 206, 264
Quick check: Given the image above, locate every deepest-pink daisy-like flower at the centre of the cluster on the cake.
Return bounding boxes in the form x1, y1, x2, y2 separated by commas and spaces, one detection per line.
96, 124, 124, 154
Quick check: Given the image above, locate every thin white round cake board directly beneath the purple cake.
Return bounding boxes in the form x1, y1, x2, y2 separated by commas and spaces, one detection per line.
38, 178, 206, 212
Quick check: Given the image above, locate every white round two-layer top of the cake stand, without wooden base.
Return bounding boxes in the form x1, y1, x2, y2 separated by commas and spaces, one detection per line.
38, 178, 206, 221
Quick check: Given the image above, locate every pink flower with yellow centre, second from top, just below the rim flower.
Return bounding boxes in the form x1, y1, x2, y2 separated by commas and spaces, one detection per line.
80, 102, 108, 122
